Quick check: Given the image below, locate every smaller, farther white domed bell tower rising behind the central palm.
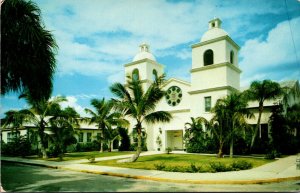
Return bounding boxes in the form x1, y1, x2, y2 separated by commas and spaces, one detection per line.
124, 43, 164, 91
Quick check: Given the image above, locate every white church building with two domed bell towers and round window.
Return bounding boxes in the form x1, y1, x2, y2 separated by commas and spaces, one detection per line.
124, 18, 299, 150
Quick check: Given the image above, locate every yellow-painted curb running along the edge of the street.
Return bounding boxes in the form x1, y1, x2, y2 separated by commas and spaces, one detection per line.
1, 160, 300, 184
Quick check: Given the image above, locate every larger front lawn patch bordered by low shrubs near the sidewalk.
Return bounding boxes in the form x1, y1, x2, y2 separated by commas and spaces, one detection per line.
89, 154, 273, 171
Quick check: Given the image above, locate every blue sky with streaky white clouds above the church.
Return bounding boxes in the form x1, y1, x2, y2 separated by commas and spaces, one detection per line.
0, 0, 300, 117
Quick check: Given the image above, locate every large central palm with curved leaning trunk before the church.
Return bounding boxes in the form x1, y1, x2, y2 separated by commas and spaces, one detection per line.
110, 75, 172, 162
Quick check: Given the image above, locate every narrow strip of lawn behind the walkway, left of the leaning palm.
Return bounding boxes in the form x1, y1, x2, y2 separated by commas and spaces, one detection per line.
26, 151, 134, 161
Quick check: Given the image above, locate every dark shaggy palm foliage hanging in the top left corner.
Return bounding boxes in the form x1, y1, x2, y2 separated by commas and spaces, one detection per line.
1, 0, 57, 100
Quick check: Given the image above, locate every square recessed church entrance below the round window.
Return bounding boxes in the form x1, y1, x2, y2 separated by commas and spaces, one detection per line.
166, 130, 183, 150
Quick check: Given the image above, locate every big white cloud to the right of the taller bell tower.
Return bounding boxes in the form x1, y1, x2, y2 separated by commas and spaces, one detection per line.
240, 17, 300, 84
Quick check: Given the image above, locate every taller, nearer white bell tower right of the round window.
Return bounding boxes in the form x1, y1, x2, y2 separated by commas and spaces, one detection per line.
189, 18, 241, 119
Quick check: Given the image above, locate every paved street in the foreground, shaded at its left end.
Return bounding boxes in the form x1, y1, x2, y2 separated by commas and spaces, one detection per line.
1, 162, 300, 192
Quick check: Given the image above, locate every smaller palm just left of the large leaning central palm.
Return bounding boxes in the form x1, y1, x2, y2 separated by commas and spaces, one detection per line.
85, 98, 129, 152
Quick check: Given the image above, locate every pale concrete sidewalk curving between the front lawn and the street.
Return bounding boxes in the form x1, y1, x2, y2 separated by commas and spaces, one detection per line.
1, 152, 300, 184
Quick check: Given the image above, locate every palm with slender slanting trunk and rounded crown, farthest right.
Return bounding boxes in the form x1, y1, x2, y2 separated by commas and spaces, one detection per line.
245, 80, 282, 149
